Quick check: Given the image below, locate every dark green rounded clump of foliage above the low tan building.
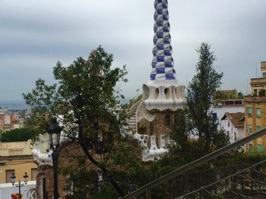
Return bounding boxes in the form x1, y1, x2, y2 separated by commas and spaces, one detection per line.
1, 128, 37, 142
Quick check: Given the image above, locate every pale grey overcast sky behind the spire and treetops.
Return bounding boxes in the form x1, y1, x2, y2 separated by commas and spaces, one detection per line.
0, 0, 266, 100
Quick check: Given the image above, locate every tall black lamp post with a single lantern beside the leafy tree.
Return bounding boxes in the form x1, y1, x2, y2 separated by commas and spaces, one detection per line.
47, 119, 63, 199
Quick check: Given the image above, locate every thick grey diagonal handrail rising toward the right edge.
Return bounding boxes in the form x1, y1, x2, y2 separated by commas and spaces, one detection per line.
122, 128, 266, 199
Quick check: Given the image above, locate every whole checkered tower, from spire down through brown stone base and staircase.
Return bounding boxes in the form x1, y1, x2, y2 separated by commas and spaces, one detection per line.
127, 0, 184, 161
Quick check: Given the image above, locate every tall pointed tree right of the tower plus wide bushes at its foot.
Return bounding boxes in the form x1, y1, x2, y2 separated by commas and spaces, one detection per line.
160, 43, 228, 167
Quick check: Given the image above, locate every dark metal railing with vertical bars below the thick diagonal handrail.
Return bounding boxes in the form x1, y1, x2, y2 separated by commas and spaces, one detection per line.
175, 159, 266, 199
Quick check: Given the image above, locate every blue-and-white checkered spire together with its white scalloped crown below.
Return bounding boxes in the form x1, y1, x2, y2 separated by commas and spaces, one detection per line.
143, 0, 184, 111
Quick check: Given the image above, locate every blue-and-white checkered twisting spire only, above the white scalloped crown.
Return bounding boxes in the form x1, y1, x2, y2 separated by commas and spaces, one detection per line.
150, 0, 175, 80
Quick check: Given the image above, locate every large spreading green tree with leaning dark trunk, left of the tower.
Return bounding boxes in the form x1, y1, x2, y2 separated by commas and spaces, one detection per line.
23, 47, 144, 198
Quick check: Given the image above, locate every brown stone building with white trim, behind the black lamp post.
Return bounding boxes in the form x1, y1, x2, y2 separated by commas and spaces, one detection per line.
34, 139, 88, 199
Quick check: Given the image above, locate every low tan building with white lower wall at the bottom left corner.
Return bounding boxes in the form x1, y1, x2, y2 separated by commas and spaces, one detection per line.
0, 140, 38, 199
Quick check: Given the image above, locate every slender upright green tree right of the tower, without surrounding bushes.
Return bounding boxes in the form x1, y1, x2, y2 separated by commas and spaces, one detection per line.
185, 43, 227, 153
